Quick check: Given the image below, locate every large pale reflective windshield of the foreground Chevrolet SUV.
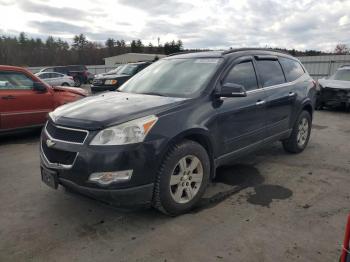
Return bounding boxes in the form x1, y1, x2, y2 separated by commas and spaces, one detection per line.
119, 58, 221, 97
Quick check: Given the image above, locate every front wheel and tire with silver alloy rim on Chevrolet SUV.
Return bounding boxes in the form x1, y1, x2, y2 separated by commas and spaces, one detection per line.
152, 140, 210, 216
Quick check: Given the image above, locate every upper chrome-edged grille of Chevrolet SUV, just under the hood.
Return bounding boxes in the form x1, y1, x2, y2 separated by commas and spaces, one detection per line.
46, 122, 88, 144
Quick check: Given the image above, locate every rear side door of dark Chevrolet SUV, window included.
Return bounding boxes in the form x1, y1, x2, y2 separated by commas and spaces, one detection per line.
255, 56, 296, 137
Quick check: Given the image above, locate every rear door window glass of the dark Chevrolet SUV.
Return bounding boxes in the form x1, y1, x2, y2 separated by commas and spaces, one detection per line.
256, 60, 285, 87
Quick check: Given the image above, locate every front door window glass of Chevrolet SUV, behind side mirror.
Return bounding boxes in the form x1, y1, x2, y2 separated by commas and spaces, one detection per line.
224, 62, 258, 91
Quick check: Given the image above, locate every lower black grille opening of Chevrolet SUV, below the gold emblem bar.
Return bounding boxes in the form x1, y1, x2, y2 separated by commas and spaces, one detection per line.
41, 140, 77, 165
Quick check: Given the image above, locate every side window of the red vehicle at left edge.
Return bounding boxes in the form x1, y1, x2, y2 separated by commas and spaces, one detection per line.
0, 72, 34, 90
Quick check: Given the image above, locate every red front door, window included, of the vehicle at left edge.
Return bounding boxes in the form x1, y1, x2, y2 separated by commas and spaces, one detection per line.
0, 71, 53, 130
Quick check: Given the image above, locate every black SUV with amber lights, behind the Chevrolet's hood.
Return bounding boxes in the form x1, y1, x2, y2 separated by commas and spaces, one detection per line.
91, 62, 151, 93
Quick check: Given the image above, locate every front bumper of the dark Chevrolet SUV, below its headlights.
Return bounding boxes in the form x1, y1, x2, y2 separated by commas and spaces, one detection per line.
40, 124, 166, 207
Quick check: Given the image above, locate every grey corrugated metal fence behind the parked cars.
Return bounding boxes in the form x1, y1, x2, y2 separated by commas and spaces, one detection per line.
28, 55, 350, 79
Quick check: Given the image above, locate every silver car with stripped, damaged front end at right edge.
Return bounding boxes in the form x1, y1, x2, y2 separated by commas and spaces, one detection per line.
316, 65, 350, 110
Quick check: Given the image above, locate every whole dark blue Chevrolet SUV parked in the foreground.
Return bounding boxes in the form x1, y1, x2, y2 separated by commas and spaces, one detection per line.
41, 49, 316, 215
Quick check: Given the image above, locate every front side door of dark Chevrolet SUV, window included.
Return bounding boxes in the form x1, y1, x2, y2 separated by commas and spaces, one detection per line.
218, 57, 266, 154
